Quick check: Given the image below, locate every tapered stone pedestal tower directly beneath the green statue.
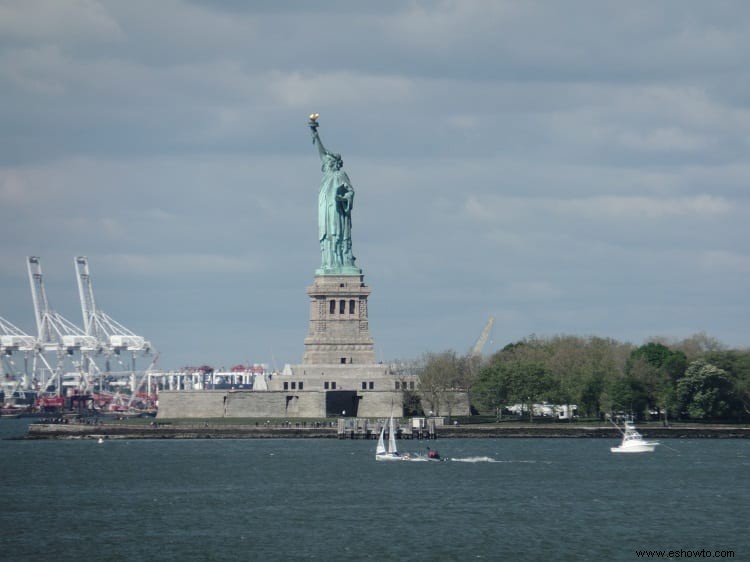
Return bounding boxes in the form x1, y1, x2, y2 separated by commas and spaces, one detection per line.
302, 274, 375, 367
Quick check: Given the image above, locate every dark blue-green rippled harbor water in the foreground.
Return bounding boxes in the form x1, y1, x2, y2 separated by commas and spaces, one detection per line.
0, 420, 750, 561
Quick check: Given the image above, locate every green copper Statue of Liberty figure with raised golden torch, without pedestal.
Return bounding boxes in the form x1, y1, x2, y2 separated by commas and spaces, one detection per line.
307, 113, 361, 275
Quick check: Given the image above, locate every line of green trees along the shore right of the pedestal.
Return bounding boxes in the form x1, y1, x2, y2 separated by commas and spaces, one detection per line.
409, 334, 750, 421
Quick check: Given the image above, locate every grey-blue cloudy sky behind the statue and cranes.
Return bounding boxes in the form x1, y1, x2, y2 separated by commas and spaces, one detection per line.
0, 0, 750, 368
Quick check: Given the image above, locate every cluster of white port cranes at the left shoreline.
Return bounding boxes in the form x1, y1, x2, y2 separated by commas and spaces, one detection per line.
0, 256, 153, 411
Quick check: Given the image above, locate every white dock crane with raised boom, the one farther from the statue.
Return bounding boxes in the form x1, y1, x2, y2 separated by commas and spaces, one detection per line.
27, 256, 98, 395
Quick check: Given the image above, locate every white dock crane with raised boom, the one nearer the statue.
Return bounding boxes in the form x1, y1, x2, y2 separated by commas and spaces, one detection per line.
74, 256, 151, 392
